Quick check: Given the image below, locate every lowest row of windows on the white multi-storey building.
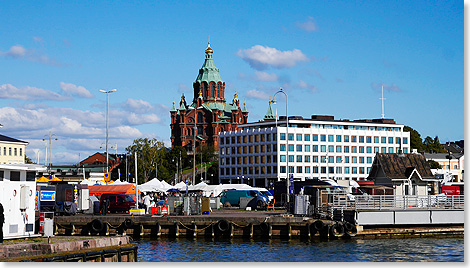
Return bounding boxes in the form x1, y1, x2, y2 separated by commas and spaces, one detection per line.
220, 166, 371, 176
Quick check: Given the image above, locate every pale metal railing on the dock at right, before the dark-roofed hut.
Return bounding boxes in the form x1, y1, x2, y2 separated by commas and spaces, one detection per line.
317, 191, 465, 215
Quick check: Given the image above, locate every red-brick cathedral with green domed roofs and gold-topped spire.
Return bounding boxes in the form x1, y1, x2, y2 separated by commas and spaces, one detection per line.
170, 41, 248, 152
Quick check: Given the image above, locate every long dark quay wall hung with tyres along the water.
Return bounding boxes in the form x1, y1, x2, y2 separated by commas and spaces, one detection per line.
51, 211, 464, 239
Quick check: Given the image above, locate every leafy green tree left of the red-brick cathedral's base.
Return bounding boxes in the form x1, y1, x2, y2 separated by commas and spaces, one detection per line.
126, 138, 167, 184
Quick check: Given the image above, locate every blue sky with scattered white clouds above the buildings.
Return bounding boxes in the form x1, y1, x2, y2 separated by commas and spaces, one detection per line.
0, 0, 467, 164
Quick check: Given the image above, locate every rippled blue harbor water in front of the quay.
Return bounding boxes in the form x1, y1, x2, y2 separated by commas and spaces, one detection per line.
135, 238, 464, 262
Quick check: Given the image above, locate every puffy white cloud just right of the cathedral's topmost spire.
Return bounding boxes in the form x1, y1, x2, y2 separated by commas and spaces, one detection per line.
237, 45, 309, 70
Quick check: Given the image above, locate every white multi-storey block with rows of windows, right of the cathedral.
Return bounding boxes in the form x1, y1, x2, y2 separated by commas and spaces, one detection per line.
219, 113, 410, 187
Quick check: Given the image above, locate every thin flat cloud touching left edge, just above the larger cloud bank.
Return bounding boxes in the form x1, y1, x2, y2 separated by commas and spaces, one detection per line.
0, 84, 70, 101
